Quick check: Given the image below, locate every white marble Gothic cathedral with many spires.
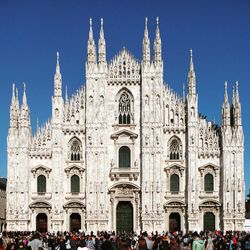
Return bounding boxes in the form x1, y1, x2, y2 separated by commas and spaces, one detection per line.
7, 18, 245, 233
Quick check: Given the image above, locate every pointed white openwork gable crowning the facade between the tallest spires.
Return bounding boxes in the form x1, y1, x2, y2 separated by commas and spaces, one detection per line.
108, 48, 141, 83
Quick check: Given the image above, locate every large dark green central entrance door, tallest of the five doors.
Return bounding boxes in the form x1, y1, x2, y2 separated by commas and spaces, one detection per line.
116, 201, 133, 233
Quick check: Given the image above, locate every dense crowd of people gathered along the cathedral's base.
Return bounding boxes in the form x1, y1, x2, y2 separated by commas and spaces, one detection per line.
0, 231, 250, 250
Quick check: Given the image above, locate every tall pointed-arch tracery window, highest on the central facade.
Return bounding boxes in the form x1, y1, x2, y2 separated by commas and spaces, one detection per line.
119, 91, 132, 124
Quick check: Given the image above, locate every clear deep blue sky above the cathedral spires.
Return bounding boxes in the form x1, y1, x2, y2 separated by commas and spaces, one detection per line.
0, 0, 250, 195
